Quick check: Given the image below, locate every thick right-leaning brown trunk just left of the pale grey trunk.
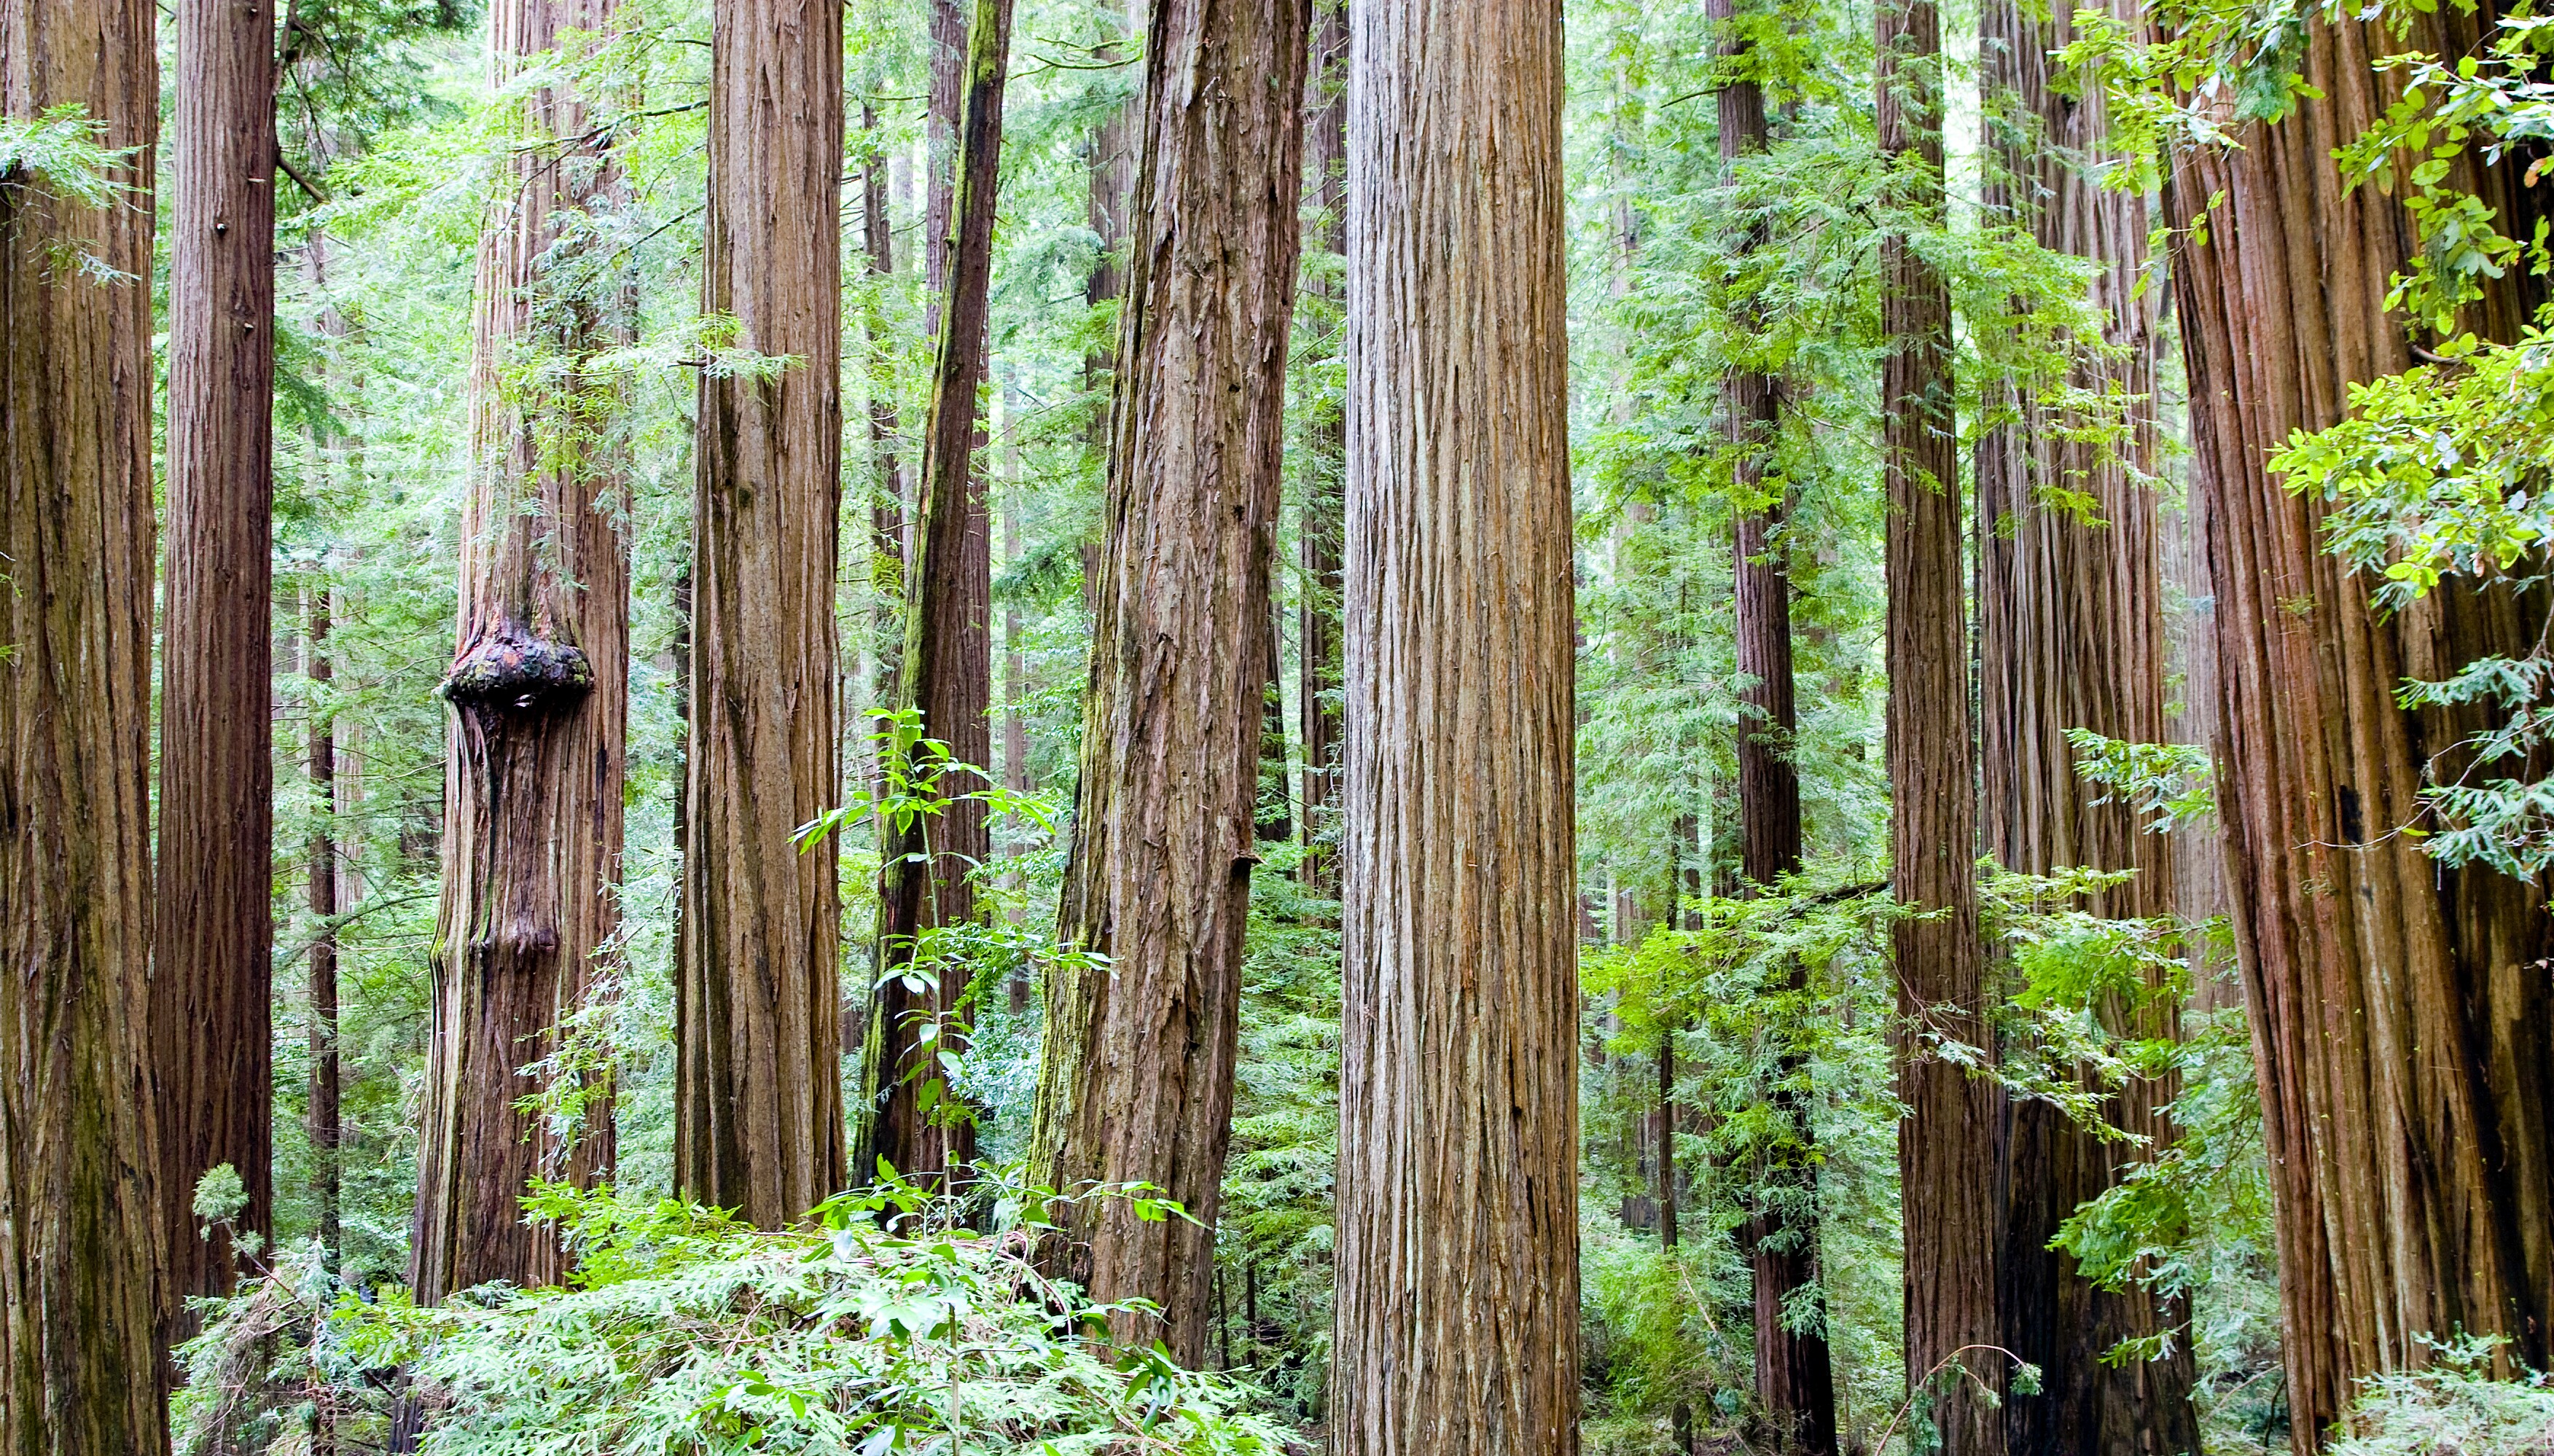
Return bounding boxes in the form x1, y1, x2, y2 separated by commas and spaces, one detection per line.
1032, 0, 1308, 1366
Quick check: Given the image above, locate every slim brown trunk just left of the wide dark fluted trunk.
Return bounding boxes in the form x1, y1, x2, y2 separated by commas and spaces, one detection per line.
1880, 0, 2005, 1456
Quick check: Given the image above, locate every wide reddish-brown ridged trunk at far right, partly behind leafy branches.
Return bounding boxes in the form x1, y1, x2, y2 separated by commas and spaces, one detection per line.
2166, 8, 2554, 1451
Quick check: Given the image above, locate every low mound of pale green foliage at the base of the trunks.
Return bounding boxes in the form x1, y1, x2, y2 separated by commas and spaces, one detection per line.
176, 1183, 1282, 1456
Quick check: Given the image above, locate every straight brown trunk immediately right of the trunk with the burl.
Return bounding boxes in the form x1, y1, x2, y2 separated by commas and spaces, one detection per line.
674, 0, 846, 1229
